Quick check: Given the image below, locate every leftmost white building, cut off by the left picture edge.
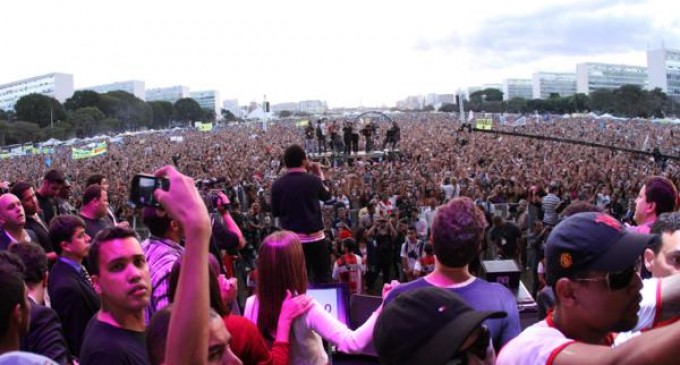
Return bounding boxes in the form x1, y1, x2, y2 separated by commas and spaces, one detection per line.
0, 73, 73, 110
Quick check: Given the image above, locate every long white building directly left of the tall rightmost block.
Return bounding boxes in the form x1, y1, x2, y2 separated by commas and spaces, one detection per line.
576, 62, 647, 95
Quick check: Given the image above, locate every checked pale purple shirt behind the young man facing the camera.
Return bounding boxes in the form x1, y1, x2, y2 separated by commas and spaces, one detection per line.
142, 236, 184, 324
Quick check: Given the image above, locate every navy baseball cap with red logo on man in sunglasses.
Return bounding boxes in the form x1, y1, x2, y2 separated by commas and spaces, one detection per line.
545, 212, 654, 286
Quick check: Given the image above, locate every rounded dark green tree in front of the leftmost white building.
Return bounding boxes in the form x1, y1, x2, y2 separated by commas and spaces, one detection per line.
14, 94, 66, 127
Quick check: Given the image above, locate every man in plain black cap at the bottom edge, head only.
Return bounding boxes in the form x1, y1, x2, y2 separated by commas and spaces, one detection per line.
373, 287, 506, 365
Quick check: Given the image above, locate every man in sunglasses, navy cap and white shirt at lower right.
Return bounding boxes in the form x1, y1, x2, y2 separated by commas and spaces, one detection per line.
497, 213, 680, 365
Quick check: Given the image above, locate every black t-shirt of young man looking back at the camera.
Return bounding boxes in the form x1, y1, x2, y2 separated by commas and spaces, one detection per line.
80, 315, 151, 365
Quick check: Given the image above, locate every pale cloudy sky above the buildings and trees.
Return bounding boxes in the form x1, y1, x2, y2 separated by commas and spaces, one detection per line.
0, 0, 680, 108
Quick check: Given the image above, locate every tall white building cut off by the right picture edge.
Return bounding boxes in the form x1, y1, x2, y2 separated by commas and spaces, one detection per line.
647, 48, 680, 97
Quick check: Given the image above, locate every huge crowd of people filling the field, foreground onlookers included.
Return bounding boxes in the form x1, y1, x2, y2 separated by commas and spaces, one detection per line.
0, 113, 680, 364
